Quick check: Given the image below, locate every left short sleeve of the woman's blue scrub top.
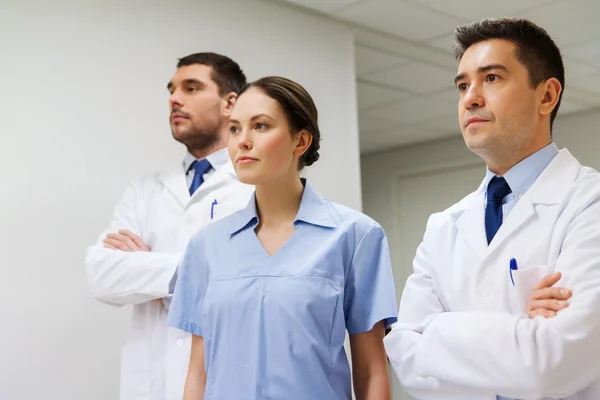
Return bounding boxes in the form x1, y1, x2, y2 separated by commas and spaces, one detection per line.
167, 238, 209, 336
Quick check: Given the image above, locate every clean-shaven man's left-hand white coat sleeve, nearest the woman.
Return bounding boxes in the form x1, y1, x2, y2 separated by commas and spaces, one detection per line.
384, 215, 481, 400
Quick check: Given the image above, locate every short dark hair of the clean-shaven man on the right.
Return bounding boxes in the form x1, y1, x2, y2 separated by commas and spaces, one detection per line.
454, 17, 565, 127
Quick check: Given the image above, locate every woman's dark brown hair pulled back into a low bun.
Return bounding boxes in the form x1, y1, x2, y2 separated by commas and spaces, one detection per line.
240, 76, 321, 169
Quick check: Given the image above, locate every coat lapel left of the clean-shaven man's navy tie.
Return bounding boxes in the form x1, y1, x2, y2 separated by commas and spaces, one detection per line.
449, 188, 488, 261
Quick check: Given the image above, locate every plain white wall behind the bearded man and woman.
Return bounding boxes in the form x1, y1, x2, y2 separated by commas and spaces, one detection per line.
0, 0, 361, 400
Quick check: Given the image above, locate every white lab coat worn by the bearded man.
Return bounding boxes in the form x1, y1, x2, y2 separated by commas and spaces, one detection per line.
86, 162, 253, 400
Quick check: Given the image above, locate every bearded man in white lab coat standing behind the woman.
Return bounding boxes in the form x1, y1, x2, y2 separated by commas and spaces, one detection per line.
86, 53, 252, 400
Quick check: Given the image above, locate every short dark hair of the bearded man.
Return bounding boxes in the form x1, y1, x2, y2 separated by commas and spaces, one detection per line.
177, 52, 246, 96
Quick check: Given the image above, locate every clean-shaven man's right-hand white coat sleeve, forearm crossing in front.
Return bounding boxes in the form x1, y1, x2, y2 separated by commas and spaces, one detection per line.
415, 195, 600, 398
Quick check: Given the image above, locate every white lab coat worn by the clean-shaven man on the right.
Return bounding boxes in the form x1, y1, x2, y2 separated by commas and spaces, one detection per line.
385, 149, 600, 400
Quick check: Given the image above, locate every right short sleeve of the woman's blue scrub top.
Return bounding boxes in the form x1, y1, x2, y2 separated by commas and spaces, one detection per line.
344, 223, 398, 334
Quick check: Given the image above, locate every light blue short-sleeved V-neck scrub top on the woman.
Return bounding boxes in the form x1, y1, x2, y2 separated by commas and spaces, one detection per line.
168, 180, 398, 400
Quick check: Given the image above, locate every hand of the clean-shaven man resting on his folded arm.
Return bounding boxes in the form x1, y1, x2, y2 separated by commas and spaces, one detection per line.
527, 272, 571, 318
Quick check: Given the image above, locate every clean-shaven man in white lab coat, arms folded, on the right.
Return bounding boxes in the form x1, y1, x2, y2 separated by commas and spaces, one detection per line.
385, 18, 600, 400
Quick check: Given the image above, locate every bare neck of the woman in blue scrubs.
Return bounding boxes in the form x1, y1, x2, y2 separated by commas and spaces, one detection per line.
256, 175, 304, 227
